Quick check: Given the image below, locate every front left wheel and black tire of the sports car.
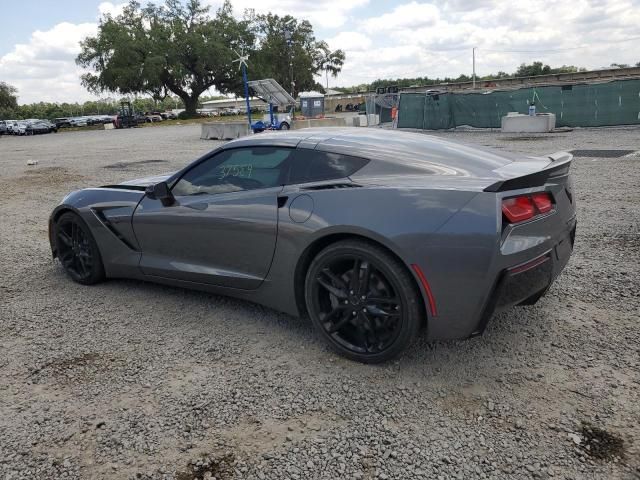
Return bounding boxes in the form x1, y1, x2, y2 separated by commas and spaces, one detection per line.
54, 212, 105, 285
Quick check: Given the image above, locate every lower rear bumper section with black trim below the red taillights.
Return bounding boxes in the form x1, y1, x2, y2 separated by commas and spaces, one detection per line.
471, 218, 576, 336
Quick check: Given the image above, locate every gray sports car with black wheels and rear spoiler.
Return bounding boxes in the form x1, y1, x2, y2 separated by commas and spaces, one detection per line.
49, 128, 576, 363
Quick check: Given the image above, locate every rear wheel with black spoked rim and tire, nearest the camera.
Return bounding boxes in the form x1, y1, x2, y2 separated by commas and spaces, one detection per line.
305, 239, 425, 363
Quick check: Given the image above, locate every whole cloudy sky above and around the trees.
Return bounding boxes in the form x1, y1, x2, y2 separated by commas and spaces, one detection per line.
0, 0, 640, 104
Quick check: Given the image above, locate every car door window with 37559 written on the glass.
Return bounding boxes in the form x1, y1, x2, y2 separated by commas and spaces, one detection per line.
172, 147, 293, 196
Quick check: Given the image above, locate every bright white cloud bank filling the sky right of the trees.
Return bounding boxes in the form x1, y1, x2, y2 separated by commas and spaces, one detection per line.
331, 0, 640, 86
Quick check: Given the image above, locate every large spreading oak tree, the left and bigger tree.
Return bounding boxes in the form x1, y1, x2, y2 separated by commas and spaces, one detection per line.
76, 0, 254, 114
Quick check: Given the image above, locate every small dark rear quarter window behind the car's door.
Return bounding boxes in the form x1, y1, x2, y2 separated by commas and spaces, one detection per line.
289, 148, 369, 183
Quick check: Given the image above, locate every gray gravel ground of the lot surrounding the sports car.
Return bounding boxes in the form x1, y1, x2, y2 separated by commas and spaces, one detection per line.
0, 126, 640, 480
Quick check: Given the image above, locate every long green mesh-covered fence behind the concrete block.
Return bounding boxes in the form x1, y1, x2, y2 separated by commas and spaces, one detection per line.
398, 80, 640, 129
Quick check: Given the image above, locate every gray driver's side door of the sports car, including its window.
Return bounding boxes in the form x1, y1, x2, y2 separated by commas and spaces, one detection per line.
133, 147, 293, 289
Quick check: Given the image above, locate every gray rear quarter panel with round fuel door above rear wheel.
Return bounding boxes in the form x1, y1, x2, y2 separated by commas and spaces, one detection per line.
258, 187, 477, 314
